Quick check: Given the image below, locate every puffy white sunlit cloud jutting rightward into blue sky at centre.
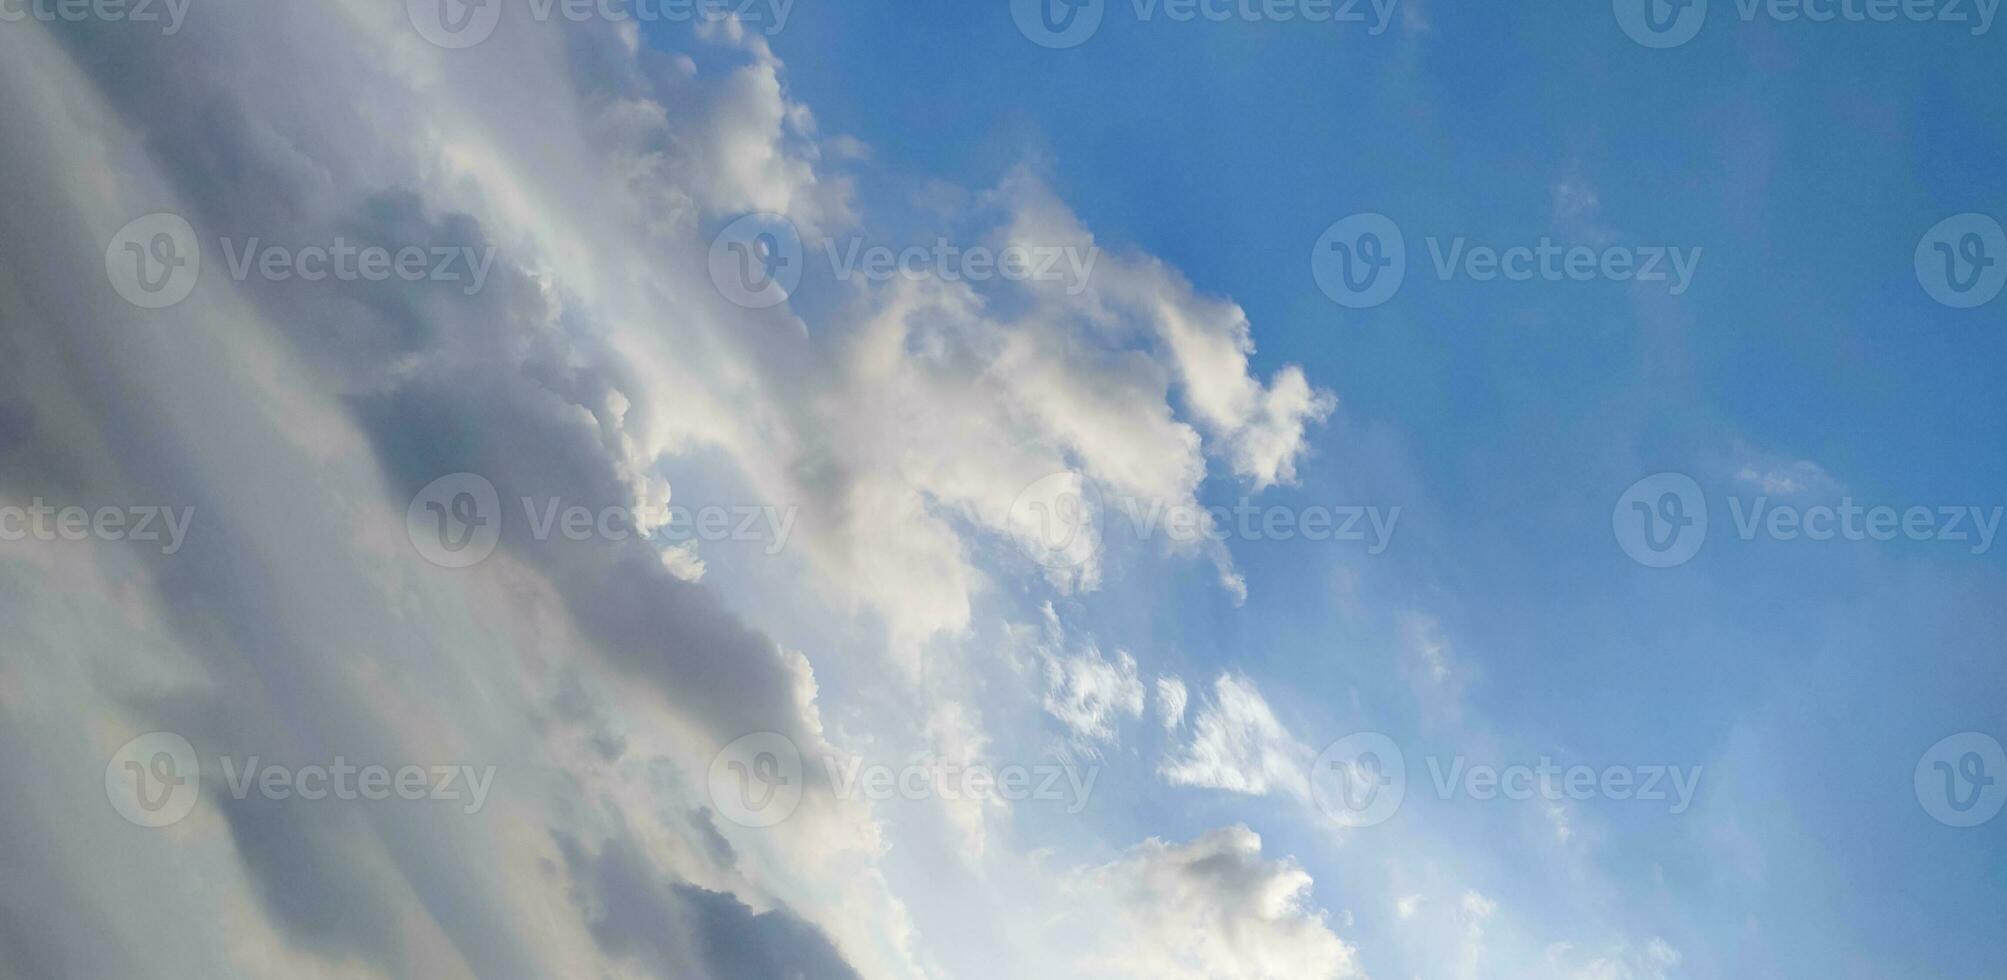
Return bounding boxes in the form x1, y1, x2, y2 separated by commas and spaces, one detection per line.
766, 171, 1335, 649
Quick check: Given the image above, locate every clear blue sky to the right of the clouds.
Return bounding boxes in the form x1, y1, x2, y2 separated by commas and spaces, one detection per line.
742, 4, 2007, 976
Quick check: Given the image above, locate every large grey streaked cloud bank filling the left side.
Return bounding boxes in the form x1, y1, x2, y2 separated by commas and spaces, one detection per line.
0, 4, 911, 976
